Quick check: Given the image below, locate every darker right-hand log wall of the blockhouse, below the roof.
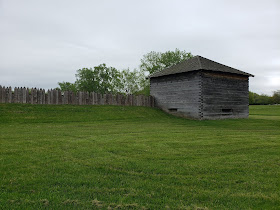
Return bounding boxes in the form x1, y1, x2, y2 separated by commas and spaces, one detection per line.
201, 71, 249, 119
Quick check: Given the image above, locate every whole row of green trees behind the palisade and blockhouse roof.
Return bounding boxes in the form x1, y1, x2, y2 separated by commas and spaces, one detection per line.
58, 49, 193, 95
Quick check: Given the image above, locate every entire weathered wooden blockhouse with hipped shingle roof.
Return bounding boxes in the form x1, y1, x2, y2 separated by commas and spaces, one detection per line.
150, 56, 253, 120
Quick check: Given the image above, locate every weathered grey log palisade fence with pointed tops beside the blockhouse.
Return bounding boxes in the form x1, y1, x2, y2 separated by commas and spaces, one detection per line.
0, 86, 155, 107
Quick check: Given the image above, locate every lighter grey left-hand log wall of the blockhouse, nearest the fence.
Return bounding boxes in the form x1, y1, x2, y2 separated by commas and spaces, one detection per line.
150, 71, 201, 119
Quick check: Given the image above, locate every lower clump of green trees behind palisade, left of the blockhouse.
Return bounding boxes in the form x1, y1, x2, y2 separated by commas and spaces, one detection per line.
58, 64, 148, 94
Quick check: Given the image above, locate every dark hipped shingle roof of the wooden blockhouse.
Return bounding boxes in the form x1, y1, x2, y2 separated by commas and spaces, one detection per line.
149, 55, 254, 78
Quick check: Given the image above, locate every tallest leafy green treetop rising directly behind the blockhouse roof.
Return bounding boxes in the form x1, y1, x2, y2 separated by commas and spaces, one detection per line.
140, 48, 193, 74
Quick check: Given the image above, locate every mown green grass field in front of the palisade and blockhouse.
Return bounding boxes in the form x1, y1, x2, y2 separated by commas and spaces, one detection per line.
0, 104, 280, 209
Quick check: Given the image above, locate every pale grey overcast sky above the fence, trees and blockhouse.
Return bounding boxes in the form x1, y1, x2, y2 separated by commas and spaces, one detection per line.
0, 0, 280, 95
